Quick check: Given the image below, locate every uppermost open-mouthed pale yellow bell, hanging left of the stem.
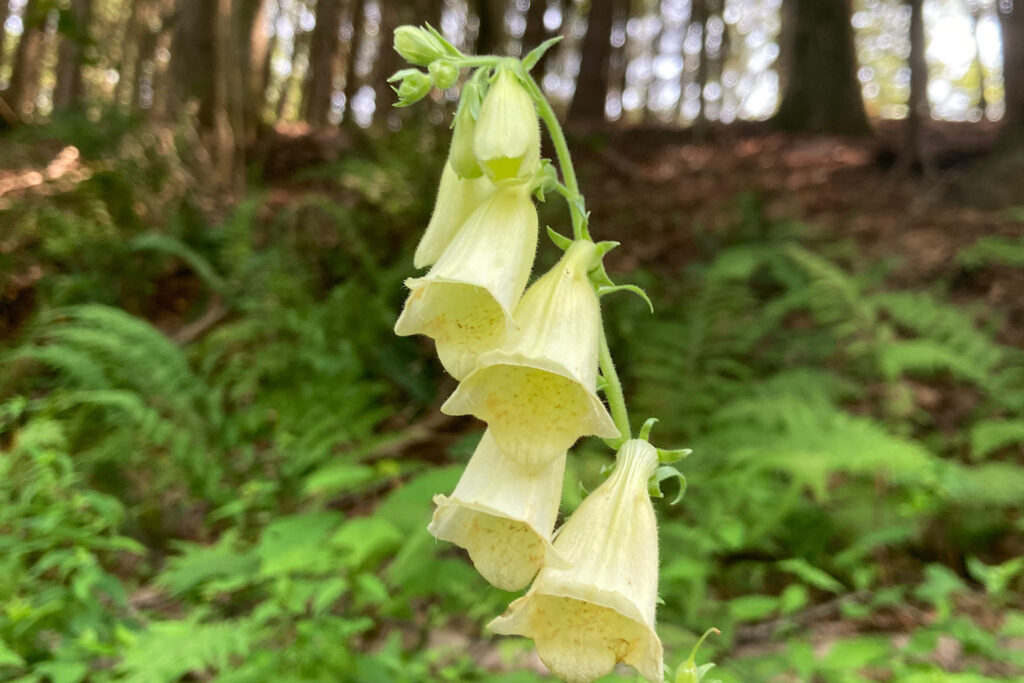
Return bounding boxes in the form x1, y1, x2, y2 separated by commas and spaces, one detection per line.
394, 184, 538, 379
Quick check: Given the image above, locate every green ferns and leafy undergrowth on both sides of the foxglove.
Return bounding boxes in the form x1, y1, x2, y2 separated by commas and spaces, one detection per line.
0, 126, 1024, 683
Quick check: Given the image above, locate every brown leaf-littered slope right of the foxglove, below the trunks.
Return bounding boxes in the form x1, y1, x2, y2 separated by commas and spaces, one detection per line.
580, 123, 1024, 345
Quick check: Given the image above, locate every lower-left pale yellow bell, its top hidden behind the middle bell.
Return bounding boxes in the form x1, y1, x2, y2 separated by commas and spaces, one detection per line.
427, 431, 568, 591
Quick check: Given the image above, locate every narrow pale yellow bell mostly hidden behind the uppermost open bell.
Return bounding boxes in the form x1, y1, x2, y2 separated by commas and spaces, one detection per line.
413, 163, 495, 268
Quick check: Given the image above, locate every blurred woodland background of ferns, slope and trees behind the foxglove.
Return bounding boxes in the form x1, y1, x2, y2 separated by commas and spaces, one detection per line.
0, 0, 1024, 683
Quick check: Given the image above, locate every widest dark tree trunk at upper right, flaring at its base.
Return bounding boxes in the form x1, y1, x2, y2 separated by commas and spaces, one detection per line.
774, 0, 870, 134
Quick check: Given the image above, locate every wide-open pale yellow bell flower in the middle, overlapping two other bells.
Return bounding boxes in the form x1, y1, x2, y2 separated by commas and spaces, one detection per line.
441, 241, 620, 468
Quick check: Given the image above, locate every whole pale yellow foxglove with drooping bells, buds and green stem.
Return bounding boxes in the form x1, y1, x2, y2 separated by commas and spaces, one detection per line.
390, 26, 710, 683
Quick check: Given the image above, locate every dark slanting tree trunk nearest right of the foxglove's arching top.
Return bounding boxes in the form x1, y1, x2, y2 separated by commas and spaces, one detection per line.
568, 0, 615, 122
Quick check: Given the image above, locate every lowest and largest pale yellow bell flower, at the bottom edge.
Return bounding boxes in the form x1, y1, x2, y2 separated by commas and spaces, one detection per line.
488, 439, 663, 683
